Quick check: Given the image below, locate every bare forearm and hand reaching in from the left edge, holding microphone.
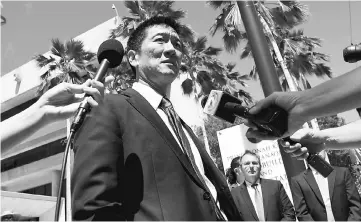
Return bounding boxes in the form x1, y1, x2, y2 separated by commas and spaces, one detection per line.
1, 80, 104, 153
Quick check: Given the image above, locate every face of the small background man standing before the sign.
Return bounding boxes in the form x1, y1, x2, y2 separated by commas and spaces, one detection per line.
241, 154, 261, 183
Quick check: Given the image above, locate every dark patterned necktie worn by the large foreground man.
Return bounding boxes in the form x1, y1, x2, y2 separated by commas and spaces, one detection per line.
159, 97, 225, 221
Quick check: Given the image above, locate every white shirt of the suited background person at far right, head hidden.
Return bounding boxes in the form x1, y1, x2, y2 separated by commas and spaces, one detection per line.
310, 154, 335, 222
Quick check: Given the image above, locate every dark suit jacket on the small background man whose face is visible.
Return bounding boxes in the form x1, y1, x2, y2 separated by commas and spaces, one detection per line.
231, 179, 296, 221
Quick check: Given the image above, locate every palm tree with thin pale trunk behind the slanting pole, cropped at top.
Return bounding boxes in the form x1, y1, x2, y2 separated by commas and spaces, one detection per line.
208, 1, 308, 91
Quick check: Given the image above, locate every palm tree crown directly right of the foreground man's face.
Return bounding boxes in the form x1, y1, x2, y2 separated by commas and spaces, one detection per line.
182, 36, 253, 104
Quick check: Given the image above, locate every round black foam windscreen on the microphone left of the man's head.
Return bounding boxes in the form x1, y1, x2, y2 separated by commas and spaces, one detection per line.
97, 39, 124, 68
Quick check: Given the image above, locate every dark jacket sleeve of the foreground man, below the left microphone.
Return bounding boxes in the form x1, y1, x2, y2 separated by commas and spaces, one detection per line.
72, 100, 124, 221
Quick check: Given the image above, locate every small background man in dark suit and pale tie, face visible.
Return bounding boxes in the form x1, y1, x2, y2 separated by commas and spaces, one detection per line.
231, 150, 296, 221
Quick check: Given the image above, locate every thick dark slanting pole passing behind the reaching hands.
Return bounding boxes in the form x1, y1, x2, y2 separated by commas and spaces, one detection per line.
237, 1, 306, 182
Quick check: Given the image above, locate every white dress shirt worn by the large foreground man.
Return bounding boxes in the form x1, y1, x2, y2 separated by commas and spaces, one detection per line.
132, 82, 217, 203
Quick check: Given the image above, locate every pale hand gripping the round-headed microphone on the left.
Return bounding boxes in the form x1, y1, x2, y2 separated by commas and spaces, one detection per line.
37, 80, 104, 121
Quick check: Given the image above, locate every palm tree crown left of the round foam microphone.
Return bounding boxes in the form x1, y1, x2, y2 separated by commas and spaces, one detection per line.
34, 39, 95, 96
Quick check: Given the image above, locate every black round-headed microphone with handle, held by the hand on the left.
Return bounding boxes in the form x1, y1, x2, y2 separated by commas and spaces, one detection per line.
70, 39, 124, 132
